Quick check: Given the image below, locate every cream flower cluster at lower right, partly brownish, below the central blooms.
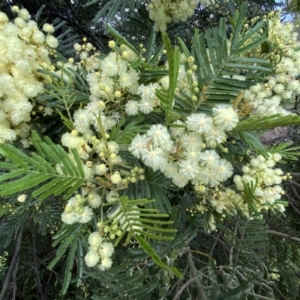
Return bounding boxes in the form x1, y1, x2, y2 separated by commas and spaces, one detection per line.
187, 153, 290, 230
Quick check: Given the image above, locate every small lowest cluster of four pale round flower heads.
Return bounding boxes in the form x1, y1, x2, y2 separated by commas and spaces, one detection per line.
84, 231, 115, 271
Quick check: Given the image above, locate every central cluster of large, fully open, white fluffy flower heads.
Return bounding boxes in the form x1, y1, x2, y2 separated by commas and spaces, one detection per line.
129, 104, 239, 189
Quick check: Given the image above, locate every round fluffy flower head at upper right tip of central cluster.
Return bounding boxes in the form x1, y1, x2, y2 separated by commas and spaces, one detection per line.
213, 104, 239, 131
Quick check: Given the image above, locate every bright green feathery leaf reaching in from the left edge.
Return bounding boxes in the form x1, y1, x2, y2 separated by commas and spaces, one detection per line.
0, 132, 85, 200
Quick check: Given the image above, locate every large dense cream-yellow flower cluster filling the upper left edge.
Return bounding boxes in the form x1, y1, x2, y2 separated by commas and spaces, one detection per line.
0, 6, 58, 143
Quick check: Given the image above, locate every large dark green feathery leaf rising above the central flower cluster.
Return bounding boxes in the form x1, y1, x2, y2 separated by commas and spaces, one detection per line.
176, 3, 272, 113
